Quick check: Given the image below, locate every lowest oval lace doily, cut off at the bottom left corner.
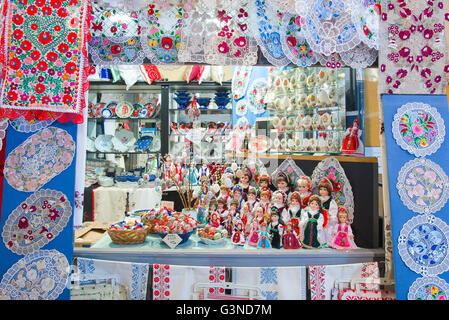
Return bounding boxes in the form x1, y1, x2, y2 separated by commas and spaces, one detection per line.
0, 250, 70, 300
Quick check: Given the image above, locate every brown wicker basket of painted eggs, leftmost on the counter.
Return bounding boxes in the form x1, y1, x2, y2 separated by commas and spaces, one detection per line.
108, 219, 149, 244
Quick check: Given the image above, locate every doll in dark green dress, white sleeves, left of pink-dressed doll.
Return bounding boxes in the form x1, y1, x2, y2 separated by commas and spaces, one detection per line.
299, 195, 327, 249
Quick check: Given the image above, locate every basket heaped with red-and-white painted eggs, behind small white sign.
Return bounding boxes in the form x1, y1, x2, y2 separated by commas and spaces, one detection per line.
153, 211, 198, 244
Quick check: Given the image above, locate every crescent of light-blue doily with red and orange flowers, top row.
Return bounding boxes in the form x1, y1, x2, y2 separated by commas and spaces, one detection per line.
280, 13, 317, 67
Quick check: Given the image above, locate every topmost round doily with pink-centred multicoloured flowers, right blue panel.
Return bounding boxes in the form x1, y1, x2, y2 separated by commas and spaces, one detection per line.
392, 102, 446, 157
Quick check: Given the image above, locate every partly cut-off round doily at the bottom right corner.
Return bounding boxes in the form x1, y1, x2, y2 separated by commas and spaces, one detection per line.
407, 277, 449, 300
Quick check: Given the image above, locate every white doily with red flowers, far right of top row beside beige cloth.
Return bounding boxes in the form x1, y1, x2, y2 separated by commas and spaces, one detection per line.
351, 0, 381, 50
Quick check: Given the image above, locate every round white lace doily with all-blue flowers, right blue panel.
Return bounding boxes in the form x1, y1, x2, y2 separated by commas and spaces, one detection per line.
398, 215, 449, 276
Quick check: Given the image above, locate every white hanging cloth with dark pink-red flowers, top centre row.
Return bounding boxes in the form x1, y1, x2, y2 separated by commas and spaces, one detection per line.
204, 0, 258, 66
